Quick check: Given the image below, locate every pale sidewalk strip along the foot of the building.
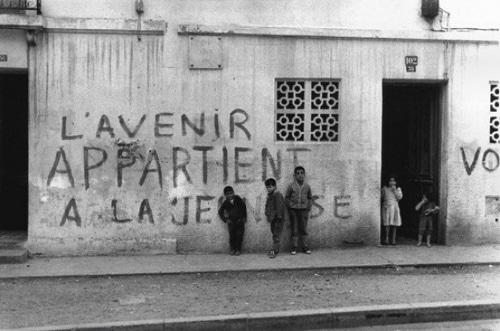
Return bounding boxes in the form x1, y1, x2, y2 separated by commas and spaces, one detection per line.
0, 245, 500, 279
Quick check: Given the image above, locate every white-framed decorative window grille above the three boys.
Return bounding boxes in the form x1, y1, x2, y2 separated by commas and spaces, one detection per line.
276, 79, 340, 142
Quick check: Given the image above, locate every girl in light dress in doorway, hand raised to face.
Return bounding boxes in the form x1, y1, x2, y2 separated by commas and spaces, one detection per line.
381, 175, 403, 246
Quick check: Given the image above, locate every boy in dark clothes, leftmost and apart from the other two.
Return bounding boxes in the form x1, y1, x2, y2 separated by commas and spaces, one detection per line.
219, 186, 247, 255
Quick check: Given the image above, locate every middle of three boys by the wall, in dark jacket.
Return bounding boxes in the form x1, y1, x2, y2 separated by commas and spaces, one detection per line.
264, 178, 285, 258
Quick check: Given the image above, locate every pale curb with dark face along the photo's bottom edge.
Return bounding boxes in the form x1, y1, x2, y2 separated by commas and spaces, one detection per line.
4, 300, 500, 331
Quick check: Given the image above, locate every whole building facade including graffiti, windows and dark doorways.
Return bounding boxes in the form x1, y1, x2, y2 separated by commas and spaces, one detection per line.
0, 0, 500, 255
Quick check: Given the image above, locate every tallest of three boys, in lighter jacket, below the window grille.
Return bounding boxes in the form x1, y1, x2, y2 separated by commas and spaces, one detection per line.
285, 166, 312, 255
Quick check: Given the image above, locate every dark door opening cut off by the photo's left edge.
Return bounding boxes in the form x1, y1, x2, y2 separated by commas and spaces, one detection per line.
0, 73, 28, 231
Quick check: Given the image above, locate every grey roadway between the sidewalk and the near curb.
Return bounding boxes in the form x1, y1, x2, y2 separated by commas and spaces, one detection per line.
0, 264, 500, 328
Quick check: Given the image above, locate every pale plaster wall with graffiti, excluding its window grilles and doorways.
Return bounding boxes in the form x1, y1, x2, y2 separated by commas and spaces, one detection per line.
1, 1, 500, 254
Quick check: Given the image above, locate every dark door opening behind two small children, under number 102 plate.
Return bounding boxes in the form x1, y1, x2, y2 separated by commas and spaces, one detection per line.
381, 83, 442, 243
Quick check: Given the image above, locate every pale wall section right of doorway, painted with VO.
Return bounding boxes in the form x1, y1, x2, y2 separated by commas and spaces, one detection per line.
444, 44, 500, 245
